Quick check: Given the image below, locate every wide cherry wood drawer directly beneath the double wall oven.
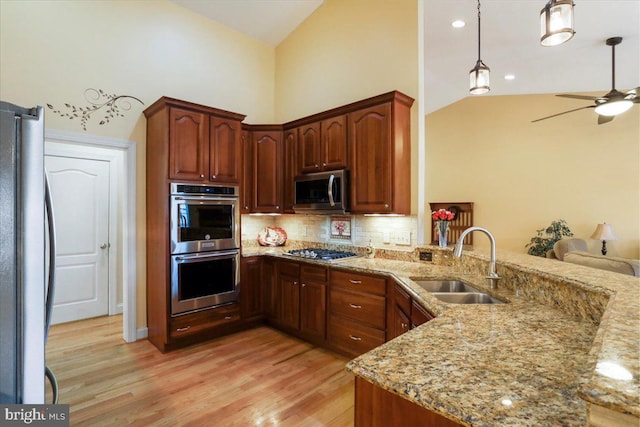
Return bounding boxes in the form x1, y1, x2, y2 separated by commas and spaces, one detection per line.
169, 304, 240, 338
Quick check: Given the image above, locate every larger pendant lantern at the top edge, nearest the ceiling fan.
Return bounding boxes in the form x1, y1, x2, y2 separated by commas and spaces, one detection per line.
540, 0, 576, 46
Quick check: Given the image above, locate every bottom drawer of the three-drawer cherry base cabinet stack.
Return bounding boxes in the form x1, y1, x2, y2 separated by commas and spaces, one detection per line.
327, 316, 385, 356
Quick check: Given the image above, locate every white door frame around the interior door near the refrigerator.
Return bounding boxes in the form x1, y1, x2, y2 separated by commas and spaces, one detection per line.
45, 129, 138, 342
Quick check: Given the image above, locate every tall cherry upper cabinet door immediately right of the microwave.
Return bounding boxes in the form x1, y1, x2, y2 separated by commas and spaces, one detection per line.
349, 103, 393, 213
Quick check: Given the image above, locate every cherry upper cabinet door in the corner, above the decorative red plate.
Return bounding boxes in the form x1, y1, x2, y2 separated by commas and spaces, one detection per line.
252, 131, 282, 213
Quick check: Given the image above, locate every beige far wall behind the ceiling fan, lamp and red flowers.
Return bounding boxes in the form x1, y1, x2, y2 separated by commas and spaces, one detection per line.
426, 94, 640, 259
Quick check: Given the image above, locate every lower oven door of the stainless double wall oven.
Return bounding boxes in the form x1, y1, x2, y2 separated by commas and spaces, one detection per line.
171, 250, 240, 316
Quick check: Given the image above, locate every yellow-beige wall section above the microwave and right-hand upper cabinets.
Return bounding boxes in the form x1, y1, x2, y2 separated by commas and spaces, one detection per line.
275, 0, 418, 213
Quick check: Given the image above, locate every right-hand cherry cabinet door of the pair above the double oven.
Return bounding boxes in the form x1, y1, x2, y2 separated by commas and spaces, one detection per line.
208, 116, 242, 185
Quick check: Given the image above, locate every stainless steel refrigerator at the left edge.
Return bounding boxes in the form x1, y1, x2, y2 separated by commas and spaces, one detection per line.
0, 101, 57, 404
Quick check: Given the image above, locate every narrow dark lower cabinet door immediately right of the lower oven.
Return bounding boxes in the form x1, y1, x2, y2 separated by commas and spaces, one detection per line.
240, 257, 265, 320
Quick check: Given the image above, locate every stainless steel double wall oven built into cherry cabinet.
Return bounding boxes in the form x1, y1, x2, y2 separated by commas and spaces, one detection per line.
170, 183, 240, 316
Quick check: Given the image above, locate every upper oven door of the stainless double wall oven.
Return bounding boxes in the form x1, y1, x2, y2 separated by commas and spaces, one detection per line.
171, 196, 240, 254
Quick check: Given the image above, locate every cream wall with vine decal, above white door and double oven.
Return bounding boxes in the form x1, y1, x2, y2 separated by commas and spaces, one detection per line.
0, 0, 275, 326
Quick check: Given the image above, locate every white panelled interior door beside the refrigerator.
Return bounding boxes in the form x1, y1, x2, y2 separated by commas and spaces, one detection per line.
45, 155, 110, 324
